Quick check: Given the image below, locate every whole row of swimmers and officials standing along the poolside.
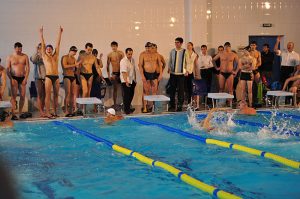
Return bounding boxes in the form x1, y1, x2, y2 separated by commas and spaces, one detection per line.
0, 27, 299, 120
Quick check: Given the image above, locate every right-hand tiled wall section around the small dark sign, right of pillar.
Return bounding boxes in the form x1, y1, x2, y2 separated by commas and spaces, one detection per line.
211, 0, 300, 50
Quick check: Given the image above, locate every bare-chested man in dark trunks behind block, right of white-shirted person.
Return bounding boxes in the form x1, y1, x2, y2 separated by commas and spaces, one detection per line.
213, 42, 238, 97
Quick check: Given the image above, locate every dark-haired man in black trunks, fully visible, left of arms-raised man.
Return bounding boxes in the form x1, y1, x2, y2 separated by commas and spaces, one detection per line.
6, 42, 30, 120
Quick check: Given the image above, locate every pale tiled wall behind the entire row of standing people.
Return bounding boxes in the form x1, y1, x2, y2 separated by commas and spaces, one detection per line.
0, 0, 300, 104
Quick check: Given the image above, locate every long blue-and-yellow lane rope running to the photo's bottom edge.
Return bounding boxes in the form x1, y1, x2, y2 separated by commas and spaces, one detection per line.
53, 121, 241, 199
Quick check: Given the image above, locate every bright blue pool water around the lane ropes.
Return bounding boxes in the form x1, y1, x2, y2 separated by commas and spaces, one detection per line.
0, 111, 300, 199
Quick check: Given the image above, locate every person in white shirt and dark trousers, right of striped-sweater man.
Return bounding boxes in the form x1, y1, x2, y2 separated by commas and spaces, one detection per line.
198, 45, 214, 92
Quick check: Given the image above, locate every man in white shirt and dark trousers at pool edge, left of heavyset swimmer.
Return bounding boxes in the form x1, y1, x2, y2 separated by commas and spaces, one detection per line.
120, 48, 136, 114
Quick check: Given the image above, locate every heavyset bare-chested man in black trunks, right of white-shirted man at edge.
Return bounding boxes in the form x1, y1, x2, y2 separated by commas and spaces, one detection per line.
139, 43, 162, 113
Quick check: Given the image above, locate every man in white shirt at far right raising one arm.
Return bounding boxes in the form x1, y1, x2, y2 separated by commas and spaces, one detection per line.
274, 36, 300, 85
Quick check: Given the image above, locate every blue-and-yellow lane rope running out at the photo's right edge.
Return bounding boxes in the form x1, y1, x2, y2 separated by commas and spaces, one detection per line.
130, 118, 300, 169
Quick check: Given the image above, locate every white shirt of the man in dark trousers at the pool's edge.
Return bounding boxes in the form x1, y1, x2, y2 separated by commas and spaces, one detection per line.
120, 56, 136, 84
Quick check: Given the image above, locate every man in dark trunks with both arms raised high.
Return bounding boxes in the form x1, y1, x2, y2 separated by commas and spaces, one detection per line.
40, 26, 63, 119
